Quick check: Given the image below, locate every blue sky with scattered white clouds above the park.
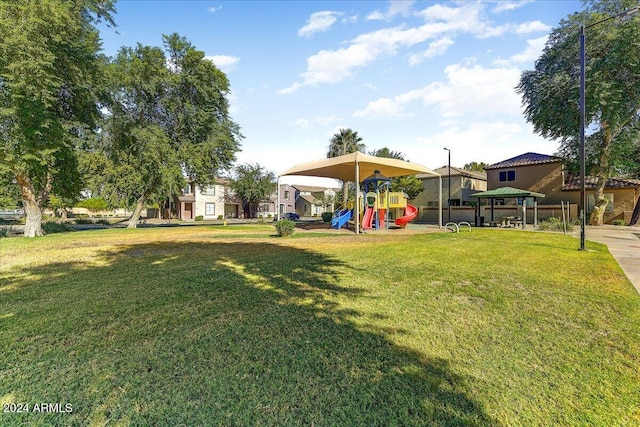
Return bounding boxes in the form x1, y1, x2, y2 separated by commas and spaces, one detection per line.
101, 0, 582, 186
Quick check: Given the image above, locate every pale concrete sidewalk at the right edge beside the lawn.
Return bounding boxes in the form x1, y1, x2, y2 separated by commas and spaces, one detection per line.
573, 225, 640, 294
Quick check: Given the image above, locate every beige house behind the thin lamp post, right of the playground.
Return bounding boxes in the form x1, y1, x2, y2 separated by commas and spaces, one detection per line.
411, 166, 487, 207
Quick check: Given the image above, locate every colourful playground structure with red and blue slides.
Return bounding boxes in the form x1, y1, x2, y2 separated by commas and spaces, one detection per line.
360, 170, 418, 230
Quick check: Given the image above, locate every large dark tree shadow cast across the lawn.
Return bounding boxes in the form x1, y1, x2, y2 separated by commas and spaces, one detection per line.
0, 242, 498, 426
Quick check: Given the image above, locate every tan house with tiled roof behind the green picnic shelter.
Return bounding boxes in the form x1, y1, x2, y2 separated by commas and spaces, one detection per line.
485, 153, 640, 223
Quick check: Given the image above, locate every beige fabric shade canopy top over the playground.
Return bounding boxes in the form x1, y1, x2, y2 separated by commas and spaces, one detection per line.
279, 152, 440, 182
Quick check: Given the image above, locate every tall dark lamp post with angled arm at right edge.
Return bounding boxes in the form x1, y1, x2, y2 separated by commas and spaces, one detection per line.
580, 6, 640, 251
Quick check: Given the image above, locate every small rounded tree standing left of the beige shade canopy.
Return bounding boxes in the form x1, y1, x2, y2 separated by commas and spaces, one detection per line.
229, 163, 277, 218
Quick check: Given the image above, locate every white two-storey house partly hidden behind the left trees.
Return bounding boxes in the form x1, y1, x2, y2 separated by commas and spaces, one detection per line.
174, 179, 240, 221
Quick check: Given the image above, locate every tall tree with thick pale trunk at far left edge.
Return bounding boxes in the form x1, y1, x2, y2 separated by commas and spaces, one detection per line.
0, 0, 114, 237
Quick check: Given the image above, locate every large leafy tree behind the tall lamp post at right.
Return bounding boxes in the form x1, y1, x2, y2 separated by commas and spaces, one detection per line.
516, 0, 640, 225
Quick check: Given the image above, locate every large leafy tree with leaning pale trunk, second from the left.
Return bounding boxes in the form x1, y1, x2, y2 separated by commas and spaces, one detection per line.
103, 34, 242, 228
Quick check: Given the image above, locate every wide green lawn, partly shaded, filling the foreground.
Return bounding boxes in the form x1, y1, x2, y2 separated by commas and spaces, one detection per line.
0, 225, 640, 426
